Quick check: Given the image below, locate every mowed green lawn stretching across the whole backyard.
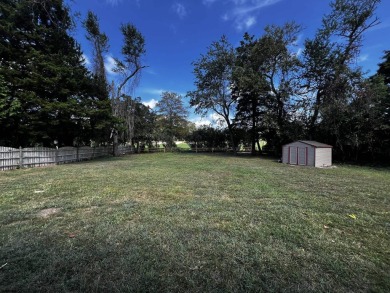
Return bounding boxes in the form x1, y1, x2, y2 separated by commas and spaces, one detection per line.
0, 153, 390, 292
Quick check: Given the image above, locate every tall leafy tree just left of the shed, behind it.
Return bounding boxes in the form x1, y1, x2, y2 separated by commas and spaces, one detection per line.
254, 22, 302, 150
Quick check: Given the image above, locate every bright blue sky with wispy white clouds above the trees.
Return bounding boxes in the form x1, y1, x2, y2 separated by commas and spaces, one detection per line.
68, 0, 390, 123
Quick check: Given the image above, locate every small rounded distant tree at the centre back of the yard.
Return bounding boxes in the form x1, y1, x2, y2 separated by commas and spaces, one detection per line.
156, 92, 188, 148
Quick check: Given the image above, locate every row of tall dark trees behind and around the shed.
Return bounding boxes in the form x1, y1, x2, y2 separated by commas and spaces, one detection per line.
188, 0, 390, 160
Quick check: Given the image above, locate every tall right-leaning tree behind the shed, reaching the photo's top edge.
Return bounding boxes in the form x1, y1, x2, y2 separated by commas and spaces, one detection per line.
302, 0, 380, 149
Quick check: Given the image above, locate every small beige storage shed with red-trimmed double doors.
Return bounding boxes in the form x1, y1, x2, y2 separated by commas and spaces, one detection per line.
282, 140, 332, 167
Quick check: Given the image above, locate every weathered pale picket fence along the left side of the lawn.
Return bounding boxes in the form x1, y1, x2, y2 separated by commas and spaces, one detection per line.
0, 146, 134, 171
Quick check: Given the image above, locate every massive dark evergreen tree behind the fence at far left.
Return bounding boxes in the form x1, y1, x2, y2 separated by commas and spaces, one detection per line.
0, 0, 99, 147
